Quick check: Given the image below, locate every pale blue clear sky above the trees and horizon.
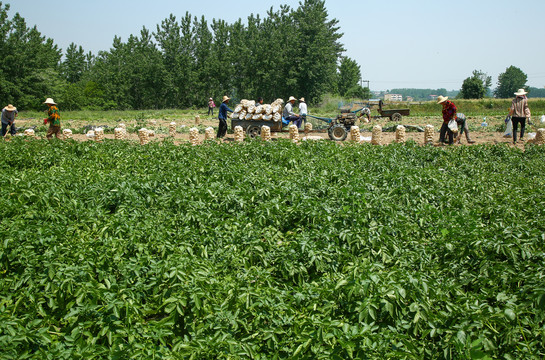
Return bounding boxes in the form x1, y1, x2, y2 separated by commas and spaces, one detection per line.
7, 0, 545, 91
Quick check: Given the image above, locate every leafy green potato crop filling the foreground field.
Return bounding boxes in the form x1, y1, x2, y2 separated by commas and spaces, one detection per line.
0, 138, 545, 360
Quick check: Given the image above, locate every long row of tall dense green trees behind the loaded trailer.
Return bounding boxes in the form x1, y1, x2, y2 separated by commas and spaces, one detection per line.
0, 0, 369, 110
